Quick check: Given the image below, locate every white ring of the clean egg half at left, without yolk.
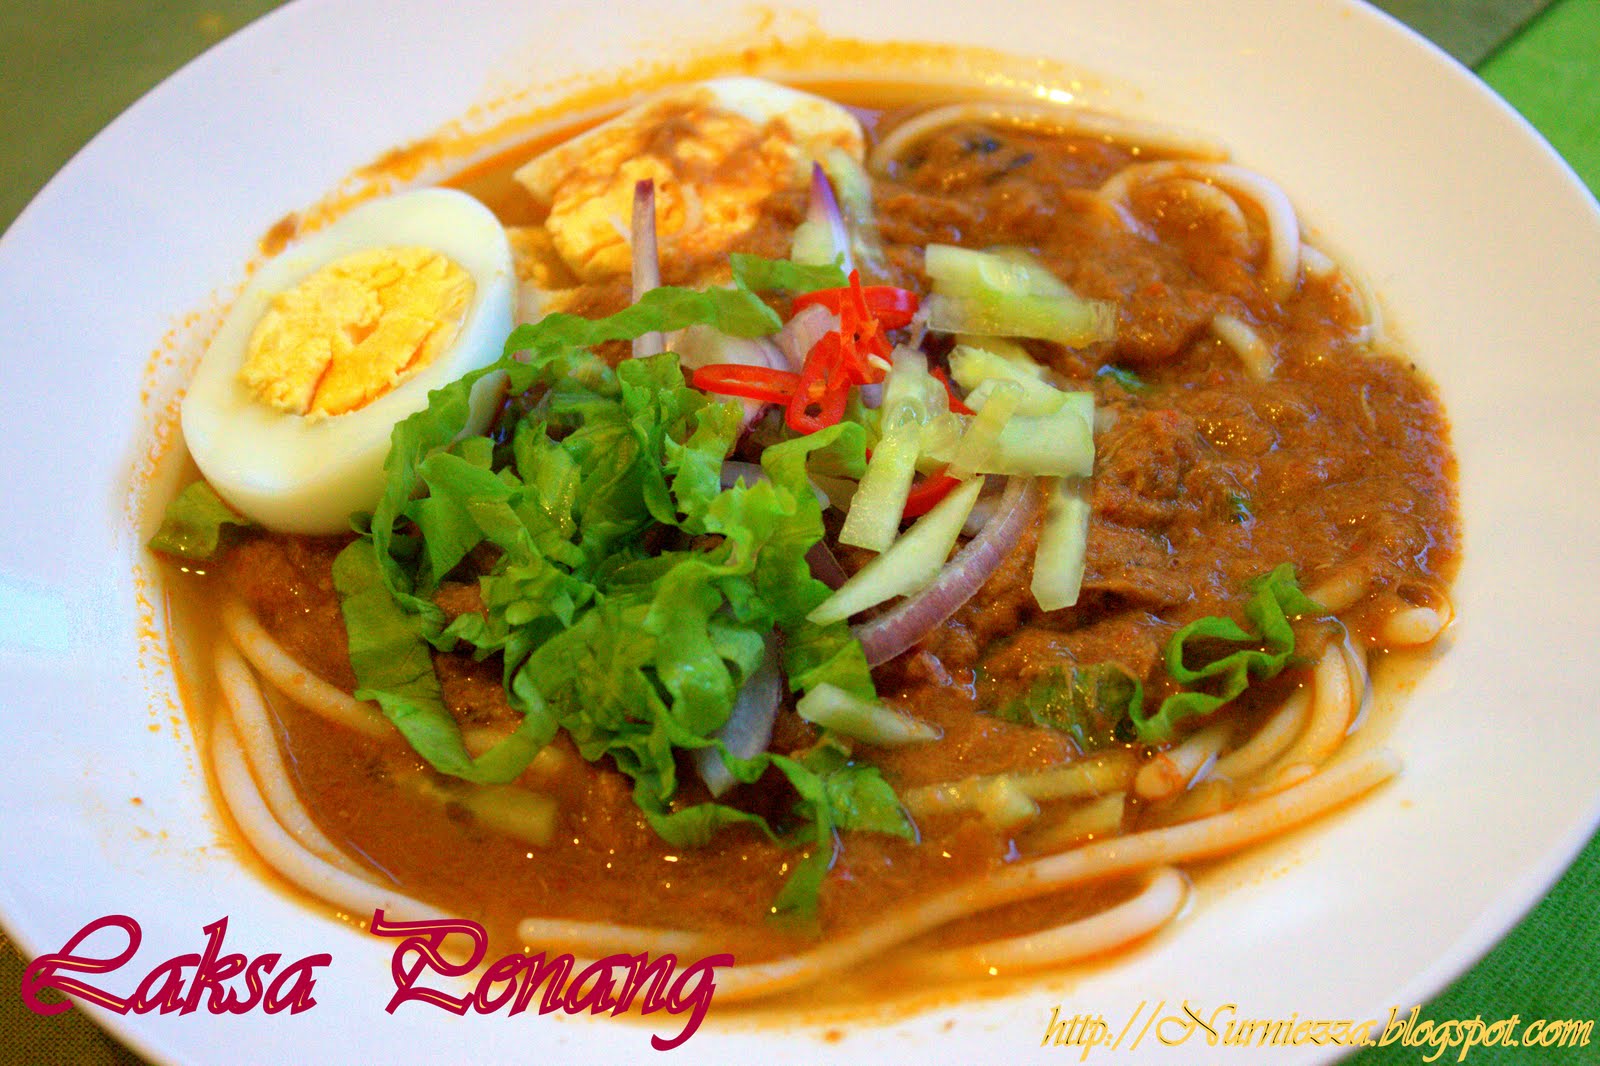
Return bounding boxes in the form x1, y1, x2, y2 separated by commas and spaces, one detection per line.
181, 189, 517, 533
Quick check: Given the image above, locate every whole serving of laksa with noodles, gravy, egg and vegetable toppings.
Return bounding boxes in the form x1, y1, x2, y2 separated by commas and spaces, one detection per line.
154, 77, 1458, 1004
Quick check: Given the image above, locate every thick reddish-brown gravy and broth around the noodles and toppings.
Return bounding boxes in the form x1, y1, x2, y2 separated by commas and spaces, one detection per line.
168, 85, 1458, 985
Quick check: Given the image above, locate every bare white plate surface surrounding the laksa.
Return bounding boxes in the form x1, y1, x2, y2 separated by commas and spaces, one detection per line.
0, 0, 1600, 1063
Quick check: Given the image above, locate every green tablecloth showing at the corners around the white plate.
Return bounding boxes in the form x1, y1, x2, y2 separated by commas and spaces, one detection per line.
0, 0, 1600, 1066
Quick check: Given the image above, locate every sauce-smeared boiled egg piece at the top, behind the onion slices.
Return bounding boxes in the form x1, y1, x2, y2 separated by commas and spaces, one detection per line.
515, 77, 864, 282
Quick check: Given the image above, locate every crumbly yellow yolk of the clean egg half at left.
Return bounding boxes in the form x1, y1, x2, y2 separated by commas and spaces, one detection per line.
240, 246, 474, 418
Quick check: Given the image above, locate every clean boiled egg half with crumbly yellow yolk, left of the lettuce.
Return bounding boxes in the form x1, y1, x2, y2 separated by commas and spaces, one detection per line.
181, 189, 515, 533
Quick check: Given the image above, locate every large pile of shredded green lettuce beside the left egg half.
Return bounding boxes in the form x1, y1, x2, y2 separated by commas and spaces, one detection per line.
334, 281, 912, 914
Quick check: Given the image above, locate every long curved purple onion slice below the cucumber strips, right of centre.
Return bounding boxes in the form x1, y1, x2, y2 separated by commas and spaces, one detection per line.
854, 477, 1038, 666
